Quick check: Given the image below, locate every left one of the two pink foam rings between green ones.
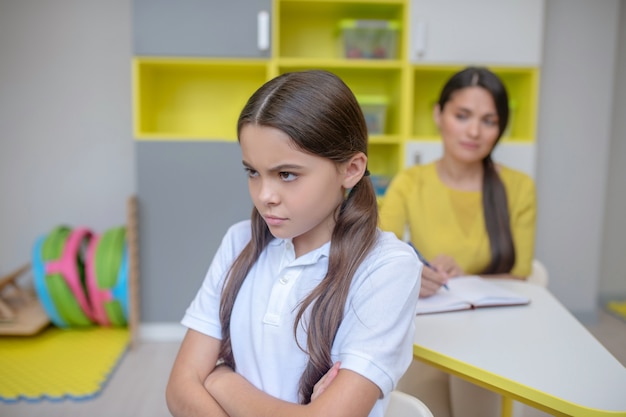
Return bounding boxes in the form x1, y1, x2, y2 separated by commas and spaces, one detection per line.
46, 227, 94, 321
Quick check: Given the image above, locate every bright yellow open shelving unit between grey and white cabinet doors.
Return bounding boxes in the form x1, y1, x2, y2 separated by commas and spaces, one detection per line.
133, 0, 539, 187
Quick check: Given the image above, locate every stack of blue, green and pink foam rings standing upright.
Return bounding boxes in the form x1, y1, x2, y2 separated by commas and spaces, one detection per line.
32, 226, 129, 327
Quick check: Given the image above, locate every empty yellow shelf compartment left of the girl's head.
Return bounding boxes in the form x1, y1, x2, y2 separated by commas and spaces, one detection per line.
133, 57, 268, 140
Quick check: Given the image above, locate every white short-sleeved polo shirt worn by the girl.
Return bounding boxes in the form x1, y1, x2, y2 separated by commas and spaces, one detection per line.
182, 220, 422, 417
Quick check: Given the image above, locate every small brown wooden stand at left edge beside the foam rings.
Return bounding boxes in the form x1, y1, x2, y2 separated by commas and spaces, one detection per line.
0, 264, 50, 336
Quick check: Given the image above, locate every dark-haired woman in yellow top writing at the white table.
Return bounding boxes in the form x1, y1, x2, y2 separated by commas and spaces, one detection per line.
381, 67, 536, 297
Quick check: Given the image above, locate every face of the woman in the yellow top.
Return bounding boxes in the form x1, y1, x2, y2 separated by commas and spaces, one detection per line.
435, 87, 500, 163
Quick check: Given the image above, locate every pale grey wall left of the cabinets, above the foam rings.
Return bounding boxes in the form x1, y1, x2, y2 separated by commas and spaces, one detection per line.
0, 0, 135, 274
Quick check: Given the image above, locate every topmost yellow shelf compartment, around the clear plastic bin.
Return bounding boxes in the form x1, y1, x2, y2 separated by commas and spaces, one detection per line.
274, 0, 406, 59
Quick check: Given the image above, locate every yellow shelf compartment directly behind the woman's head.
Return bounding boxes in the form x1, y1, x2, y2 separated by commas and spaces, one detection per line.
412, 66, 539, 142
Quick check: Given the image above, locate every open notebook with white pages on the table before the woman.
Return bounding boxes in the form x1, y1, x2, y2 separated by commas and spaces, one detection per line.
417, 275, 530, 314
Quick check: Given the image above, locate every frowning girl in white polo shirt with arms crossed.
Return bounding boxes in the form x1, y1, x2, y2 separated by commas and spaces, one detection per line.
166, 71, 421, 417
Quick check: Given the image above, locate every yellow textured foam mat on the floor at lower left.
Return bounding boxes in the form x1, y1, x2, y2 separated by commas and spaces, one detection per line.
0, 326, 130, 402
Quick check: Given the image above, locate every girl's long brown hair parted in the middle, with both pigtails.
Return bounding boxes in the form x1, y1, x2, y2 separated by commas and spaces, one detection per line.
219, 70, 378, 404
